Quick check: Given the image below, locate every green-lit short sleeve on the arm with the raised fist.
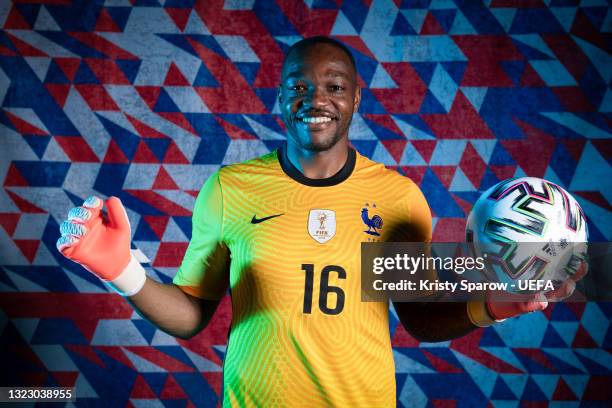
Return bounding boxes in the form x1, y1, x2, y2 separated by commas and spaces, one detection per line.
173, 172, 230, 300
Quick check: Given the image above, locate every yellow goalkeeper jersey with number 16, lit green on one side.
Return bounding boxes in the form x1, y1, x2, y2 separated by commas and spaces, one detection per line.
174, 149, 431, 407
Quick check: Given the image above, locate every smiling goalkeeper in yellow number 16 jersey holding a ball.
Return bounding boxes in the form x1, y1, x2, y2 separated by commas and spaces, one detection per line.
58, 37, 545, 407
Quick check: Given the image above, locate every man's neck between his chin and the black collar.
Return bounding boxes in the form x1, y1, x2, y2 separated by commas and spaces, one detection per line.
287, 137, 349, 179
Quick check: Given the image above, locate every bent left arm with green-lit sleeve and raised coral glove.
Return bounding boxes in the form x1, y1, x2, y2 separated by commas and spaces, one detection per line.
57, 172, 229, 338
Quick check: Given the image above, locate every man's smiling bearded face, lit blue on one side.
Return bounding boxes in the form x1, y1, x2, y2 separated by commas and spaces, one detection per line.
279, 43, 361, 152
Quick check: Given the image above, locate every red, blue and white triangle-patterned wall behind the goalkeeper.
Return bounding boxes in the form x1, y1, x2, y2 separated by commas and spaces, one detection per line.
0, 0, 612, 407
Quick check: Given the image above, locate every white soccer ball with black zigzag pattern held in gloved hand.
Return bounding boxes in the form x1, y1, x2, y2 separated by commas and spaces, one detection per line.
466, 177, 588, 294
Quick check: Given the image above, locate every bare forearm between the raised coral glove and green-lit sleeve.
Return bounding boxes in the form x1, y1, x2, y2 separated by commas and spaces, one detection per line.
127, 277, 218, 338
